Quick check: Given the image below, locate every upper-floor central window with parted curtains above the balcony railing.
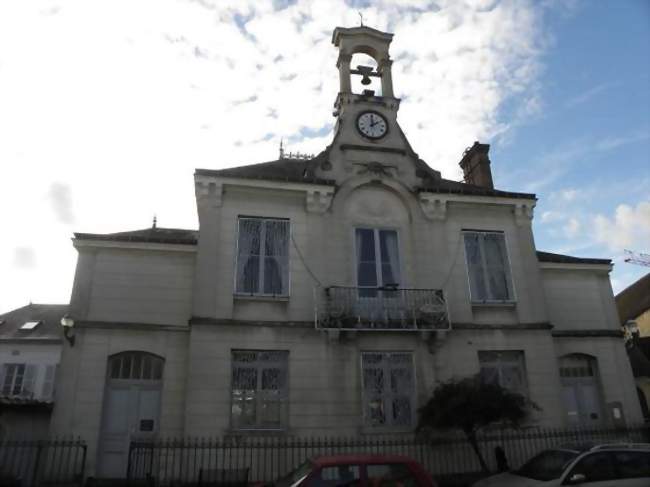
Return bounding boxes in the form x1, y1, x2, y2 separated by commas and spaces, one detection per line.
355, 228, 401, 297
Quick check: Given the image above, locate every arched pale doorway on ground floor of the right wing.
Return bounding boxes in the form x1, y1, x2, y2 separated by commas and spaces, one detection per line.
560, 353, 604, 426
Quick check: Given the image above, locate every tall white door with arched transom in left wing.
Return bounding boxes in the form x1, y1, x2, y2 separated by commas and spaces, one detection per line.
97, 352, 162, 478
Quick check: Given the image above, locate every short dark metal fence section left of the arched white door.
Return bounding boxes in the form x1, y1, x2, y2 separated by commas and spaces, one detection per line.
0, 438, 86, 487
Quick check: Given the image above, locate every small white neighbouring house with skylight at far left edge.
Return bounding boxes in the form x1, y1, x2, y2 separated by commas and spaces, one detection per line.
0, 304, 68, 439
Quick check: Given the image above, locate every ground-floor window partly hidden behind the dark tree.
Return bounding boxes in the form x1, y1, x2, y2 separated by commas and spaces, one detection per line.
478, 350, 528, 396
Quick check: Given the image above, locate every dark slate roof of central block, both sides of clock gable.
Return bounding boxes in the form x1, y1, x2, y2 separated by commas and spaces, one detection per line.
195, 157, 535, 199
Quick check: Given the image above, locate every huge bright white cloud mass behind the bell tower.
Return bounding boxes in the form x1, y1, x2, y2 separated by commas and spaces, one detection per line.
0, 0, 545, 311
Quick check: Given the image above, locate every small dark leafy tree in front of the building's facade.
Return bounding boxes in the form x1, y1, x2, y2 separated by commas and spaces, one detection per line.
417, 375, 539, 472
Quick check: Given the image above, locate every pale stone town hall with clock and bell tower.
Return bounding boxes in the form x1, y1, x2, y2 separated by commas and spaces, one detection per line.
52, 27, 641, 476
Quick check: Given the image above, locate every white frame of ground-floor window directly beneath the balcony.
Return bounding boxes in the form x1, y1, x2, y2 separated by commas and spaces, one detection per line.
359, 350, 418, 432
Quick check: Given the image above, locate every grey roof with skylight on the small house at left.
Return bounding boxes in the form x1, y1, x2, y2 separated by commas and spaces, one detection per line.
0, 303, 68, 340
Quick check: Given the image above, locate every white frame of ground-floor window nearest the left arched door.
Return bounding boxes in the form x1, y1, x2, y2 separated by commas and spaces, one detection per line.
229, 348, 289, 432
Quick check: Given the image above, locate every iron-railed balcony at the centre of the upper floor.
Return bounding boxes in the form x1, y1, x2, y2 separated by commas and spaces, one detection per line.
316, 286, 450, 331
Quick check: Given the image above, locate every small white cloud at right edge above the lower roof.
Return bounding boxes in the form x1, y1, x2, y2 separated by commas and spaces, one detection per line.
594, 201, 650, 252
